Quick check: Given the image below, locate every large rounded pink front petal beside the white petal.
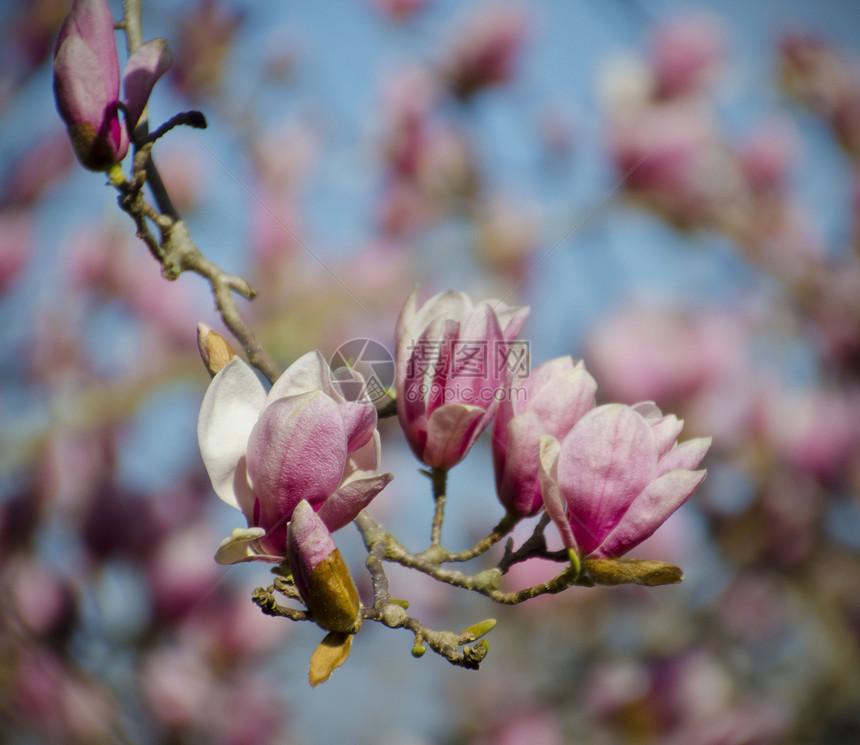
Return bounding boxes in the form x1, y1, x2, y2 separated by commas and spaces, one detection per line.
248, 391, 347, 531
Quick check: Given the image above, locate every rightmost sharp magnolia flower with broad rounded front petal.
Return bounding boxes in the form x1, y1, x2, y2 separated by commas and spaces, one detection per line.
540, 403, 711, 558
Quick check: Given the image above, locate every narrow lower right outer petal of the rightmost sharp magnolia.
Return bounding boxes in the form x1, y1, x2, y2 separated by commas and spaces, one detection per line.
593, 470, 705, 557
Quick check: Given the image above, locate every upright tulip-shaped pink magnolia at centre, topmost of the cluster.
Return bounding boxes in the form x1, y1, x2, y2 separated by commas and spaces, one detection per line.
395, 290, 529, 469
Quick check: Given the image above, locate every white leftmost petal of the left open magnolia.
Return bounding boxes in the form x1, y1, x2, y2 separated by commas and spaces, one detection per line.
197, 357, 266, 520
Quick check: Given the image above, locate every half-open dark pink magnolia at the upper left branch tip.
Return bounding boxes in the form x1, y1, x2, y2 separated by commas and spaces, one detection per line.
54, 0, 170, 171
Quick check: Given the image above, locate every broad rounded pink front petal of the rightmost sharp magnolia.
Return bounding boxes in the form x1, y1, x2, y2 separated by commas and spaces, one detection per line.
558, 404, 657, 556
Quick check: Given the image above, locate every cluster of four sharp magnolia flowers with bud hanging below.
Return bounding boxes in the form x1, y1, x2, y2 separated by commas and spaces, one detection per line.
198, 291, 710, 631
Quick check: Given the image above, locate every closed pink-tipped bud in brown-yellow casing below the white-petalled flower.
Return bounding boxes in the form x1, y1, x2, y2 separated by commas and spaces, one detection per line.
288, 499, 361, 633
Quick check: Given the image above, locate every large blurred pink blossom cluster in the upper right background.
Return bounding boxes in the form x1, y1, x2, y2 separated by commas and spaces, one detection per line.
602, 15, 824, 281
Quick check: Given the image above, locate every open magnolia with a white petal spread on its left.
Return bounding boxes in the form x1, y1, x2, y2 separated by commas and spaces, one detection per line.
197, 351, 393, 564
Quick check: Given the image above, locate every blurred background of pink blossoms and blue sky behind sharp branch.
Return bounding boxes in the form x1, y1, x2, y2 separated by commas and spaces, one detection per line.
0, 0, 860, 745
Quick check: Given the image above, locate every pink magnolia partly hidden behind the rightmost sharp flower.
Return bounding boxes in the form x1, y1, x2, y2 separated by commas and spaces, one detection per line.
493, 357, 597, 516
